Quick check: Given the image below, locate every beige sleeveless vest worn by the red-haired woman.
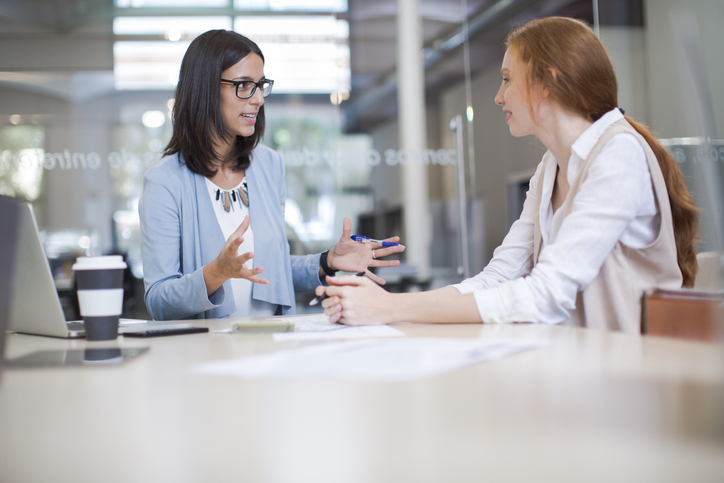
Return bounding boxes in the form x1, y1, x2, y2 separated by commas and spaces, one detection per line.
533, 119, 683, 334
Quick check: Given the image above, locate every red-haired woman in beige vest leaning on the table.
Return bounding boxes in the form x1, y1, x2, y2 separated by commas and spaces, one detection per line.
317, 17, 699, 333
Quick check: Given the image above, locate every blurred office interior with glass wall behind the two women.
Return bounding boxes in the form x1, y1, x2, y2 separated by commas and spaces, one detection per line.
0, 0, 724, 316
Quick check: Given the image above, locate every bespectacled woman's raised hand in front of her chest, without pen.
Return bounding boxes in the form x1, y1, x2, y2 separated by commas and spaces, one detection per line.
204, 215, 269, 295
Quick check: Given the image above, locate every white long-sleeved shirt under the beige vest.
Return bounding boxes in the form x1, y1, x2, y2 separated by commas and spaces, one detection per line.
453, 109, 661, 324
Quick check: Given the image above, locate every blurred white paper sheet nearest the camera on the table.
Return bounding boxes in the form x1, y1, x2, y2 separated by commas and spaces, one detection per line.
190, 337, 543, 382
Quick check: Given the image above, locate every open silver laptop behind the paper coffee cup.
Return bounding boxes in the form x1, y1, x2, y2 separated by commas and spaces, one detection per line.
6, 203, 156, 338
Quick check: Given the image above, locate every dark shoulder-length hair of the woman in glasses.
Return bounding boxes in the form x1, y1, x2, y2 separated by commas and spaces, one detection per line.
163, 30, 265, 177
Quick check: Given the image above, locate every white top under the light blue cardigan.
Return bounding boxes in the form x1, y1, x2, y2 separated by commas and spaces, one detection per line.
206, 178, 275, 317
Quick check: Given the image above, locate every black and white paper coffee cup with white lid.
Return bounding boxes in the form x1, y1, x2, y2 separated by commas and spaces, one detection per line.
73, 255, 126, 340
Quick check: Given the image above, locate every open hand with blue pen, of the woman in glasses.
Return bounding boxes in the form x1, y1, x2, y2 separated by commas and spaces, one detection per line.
327, 217, 405, 285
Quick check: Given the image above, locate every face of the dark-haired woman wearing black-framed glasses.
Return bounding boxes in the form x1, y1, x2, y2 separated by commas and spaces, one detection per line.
221, 53, 265, 142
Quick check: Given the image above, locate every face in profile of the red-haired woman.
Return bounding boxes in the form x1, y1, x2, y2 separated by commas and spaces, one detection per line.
495, 50, 538, 137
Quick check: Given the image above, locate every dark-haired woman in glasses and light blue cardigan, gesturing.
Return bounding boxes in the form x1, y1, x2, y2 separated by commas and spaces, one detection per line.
139, 30, 404, 320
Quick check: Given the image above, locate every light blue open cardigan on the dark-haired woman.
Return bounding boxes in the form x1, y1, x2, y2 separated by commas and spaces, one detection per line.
138, 145, 322, 320
